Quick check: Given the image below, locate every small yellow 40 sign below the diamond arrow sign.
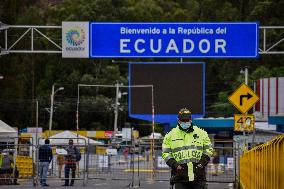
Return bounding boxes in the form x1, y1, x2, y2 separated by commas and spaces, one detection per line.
234, 114, 254, 131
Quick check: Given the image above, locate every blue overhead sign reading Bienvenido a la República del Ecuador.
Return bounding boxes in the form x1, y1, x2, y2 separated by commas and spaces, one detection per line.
89, 22, 258, 58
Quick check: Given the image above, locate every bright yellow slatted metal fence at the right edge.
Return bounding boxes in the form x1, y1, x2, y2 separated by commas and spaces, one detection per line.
240, 135, 284, 189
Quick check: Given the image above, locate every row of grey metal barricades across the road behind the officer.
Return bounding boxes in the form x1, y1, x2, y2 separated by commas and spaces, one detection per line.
1, 138, 243, 186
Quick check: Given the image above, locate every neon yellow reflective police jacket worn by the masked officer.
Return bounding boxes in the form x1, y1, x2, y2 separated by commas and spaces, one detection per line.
162, 126, 213, 181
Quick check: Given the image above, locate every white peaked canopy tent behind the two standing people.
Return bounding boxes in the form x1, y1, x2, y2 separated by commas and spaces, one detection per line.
49, 131, 102, 145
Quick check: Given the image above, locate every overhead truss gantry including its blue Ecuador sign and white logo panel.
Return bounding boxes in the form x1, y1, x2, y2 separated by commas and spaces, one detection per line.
0, 21, 284, 58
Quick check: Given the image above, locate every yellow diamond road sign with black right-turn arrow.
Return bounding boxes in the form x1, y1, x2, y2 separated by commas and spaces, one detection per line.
228, 83, 259, 114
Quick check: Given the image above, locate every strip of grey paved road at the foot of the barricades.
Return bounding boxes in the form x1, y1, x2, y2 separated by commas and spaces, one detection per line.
0, 180, 233, 189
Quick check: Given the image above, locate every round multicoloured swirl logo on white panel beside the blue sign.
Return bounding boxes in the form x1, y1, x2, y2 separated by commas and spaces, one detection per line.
66, 26, 86, 47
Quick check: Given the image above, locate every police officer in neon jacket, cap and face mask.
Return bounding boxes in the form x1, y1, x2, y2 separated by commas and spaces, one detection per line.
162, 108, 213, 189
